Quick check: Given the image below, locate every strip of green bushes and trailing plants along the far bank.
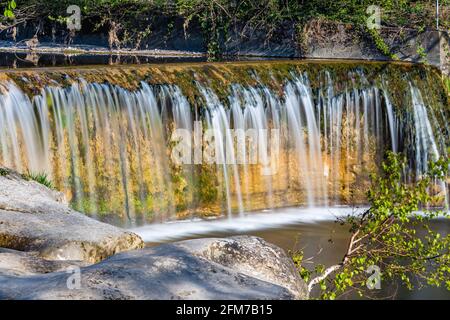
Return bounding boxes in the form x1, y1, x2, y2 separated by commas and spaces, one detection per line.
0, 0, 450, 56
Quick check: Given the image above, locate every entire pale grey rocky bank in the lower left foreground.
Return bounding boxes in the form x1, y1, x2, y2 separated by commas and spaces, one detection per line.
0, 168, 307, 299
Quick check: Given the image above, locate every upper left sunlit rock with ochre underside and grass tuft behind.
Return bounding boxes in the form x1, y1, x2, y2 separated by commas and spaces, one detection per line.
0, 169, 144, 263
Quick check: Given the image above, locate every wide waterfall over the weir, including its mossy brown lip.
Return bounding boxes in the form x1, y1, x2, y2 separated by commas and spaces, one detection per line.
0, 62, 450, 224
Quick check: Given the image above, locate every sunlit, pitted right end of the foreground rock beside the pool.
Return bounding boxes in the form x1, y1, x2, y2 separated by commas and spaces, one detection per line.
178, 236, 307, 299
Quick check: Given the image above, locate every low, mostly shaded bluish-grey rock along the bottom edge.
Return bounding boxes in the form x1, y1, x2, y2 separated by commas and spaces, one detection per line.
0, 237, 306, 299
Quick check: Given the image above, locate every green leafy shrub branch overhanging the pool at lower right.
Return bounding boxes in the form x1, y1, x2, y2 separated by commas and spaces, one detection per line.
294, 153, 450, 299
